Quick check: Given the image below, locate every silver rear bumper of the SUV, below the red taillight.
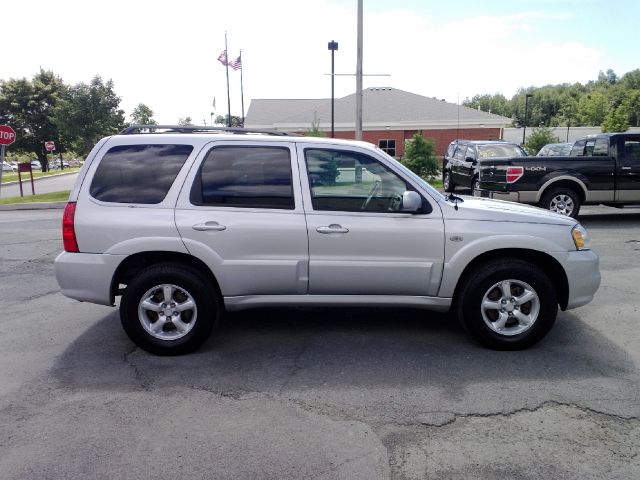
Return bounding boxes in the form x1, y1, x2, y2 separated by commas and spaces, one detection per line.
53, 252, 126, 305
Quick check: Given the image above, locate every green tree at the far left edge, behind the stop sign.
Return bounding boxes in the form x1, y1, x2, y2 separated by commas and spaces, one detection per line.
0, 69, 68, 171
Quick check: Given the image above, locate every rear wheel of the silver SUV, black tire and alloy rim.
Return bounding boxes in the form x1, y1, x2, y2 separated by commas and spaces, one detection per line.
120, 263, 221, 355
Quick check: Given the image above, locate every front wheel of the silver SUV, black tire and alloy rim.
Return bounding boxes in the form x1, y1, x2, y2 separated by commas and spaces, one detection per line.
456, 259, 558, 350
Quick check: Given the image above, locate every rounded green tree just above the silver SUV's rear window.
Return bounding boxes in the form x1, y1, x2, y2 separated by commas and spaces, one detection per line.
56, 76, 125, 155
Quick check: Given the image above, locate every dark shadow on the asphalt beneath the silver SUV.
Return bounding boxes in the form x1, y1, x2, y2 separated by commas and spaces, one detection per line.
51, 308, 636, 396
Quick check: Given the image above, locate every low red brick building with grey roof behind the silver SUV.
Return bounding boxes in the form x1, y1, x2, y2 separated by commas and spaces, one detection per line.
245, 87, 511, 157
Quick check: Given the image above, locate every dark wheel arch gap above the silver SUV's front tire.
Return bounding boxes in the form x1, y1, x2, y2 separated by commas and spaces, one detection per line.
453, 248, 569, 310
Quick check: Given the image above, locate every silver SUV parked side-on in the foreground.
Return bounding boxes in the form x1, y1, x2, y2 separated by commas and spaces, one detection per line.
55, 126, 600, 354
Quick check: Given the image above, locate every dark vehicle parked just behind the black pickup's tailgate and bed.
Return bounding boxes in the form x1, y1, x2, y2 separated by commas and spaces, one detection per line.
442, 140, 527, 195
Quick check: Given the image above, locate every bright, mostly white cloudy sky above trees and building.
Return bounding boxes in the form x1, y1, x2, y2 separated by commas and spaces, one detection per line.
0, 0, 640, 124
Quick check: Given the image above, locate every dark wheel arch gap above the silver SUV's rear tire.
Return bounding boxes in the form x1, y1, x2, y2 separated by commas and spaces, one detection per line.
111, 251, 222, 305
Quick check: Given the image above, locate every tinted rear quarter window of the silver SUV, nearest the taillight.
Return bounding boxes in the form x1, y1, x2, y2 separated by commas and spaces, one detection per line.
89, 144, 193, 204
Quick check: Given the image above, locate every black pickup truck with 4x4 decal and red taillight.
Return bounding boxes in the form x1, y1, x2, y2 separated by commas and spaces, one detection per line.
475, 133, 640, 218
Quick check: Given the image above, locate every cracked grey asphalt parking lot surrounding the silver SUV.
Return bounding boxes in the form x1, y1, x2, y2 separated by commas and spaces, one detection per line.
0, 207, 640, 480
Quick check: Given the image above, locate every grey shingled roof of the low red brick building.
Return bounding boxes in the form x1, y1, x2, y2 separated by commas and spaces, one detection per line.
245, 87, 511, 130
